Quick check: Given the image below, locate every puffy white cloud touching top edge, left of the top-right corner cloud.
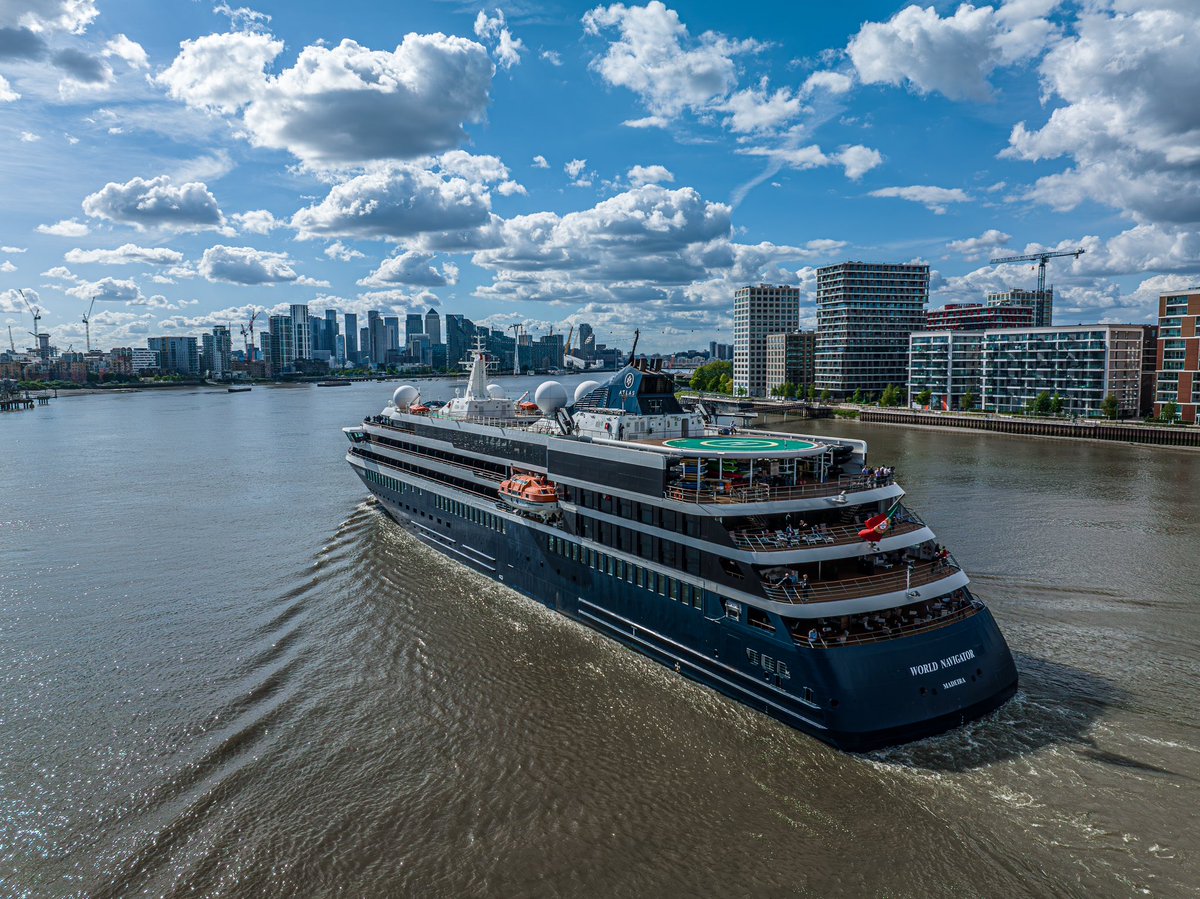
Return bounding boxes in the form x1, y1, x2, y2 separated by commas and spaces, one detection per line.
846, 0, 1058, 100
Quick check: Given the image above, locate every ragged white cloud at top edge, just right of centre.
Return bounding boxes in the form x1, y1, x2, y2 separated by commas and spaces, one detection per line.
583, 0, 761, 118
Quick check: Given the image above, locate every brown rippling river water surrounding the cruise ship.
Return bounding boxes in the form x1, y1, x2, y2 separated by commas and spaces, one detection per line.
0, 384, 1200, 897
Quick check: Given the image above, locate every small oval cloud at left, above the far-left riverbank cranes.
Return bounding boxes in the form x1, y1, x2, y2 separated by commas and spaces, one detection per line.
83, 175, 224, 230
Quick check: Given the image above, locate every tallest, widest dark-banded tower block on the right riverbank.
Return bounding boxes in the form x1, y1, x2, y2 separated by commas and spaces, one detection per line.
816, 262, 929, 397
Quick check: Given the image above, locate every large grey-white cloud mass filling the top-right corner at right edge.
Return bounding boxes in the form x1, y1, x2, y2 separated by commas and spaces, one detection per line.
1001, 4, 1200, 226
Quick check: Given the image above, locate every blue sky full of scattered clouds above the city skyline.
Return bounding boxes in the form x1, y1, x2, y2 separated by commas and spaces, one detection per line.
0, 0, 1200, 349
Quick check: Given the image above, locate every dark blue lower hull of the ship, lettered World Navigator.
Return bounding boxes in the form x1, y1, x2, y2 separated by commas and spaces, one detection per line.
365, 480, 1016, 751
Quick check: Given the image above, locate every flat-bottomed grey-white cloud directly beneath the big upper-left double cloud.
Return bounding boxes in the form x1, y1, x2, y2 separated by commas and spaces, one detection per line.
292, 163, 491, 238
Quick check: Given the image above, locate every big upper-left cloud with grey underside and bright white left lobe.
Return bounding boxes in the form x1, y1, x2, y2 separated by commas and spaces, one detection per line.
158, 31, 494, 166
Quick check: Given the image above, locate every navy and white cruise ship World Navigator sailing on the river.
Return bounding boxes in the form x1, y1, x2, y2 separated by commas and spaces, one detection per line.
344, 347, 1018, 751
